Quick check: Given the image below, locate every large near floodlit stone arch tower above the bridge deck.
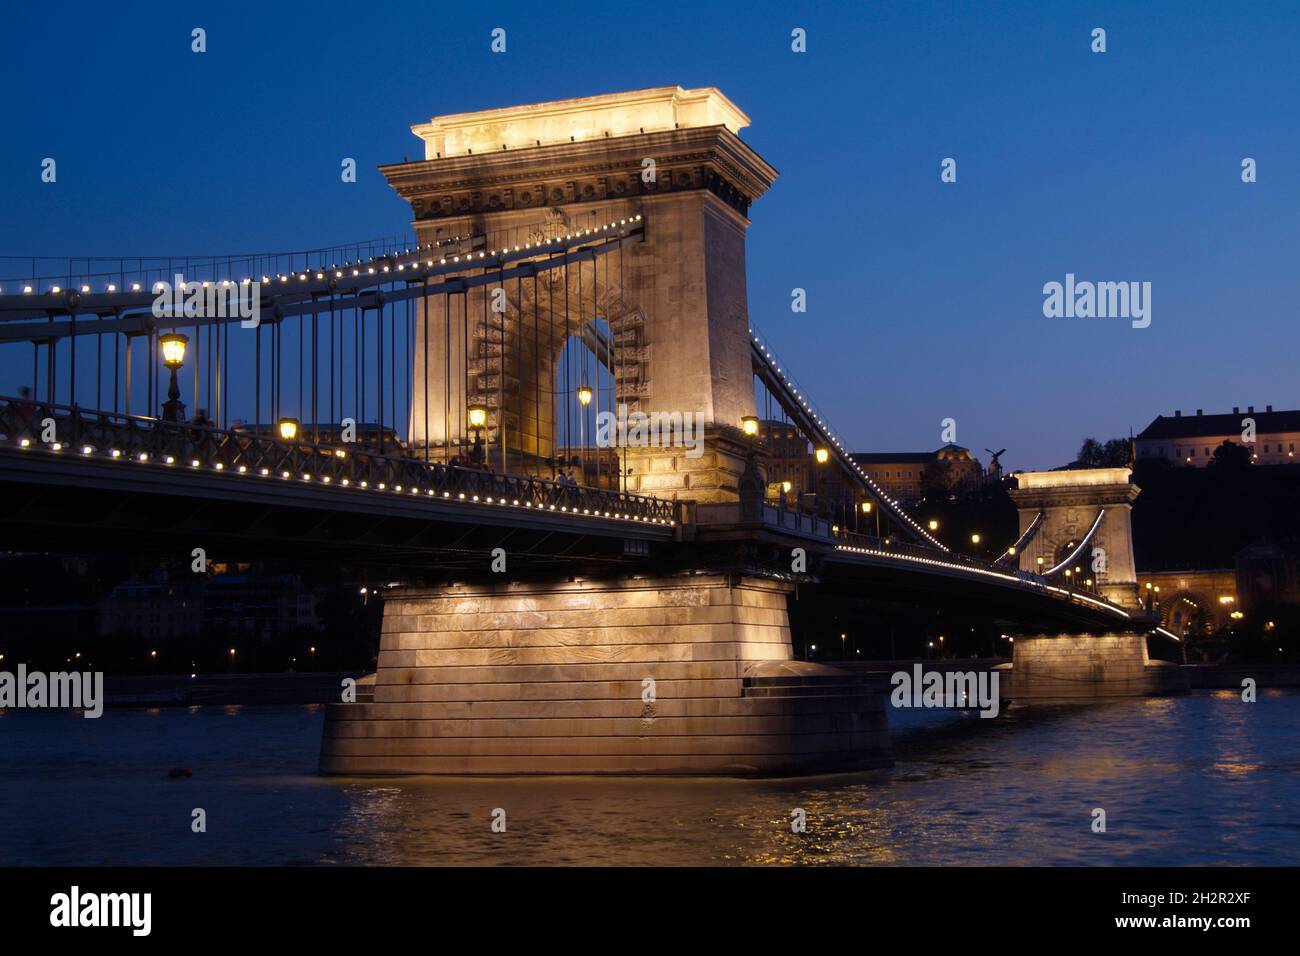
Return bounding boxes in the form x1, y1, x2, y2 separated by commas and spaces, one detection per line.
382, 86, 776, 502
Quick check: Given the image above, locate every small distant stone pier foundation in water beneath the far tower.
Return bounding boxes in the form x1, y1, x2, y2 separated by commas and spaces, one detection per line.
1001, 633, 1188, 702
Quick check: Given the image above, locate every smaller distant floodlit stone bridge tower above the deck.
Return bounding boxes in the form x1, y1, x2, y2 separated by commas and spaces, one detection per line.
1011, 468, 1141, 607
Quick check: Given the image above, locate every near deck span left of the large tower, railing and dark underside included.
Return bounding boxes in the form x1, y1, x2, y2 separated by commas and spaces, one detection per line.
0, 399, 676, 566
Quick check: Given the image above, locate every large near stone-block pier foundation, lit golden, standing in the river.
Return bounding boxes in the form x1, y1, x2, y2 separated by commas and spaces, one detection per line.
321, 575, 892, 775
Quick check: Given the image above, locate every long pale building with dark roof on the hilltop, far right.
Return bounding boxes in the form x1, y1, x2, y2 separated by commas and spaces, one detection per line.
1134, 405, 1300, 468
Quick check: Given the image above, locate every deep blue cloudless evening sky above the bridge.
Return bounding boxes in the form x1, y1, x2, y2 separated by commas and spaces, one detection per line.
0, 1, 1300, 467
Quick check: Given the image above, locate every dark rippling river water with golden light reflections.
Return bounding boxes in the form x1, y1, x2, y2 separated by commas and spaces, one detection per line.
0, 691, 1300, 866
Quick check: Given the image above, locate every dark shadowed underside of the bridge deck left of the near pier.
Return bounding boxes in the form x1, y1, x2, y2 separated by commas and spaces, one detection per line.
0, 463, 671, 579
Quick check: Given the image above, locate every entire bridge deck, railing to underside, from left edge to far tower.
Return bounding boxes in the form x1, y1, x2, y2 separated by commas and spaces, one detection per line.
0, 399, 1144, 630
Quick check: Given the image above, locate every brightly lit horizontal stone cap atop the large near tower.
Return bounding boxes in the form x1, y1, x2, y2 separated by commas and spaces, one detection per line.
411, 86, 749, 159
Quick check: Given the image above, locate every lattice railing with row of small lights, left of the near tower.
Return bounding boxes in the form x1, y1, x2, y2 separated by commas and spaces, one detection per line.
0, 397, 675, 524
